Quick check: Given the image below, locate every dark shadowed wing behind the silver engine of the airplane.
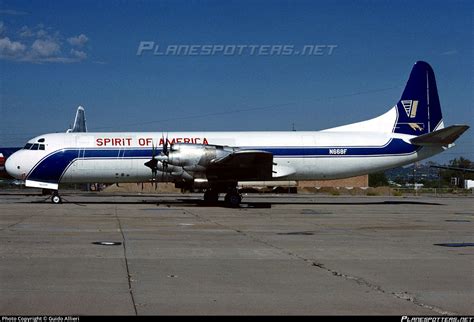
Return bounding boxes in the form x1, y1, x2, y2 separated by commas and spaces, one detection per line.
206, 150, 273, 181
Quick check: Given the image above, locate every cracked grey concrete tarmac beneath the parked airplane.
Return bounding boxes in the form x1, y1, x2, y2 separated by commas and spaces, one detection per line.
0, 191, 474, 315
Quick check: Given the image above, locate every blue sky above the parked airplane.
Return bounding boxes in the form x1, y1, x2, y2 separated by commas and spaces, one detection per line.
0, 0, 474, 162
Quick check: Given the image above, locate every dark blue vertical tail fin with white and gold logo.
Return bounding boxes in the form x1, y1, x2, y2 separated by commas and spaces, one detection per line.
394, 61, 443, 135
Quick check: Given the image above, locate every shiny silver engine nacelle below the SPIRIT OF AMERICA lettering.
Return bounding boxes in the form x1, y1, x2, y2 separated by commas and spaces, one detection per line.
164, 143, 234, 171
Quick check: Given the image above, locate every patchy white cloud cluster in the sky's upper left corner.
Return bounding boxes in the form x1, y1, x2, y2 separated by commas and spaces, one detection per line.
0, 21, 89, 63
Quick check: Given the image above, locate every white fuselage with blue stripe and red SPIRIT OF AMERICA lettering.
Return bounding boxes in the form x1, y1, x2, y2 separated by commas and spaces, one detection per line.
3, 131, 442, 189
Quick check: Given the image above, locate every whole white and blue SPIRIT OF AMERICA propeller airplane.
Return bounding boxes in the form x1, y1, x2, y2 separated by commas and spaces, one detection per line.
5, 61, 469, 207
